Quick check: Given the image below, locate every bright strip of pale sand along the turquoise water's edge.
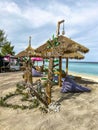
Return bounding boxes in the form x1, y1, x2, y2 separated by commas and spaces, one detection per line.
69, 71, 98, 82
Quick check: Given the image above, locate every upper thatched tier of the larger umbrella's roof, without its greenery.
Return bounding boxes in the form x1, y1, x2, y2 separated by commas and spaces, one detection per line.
36, 35, 89, 55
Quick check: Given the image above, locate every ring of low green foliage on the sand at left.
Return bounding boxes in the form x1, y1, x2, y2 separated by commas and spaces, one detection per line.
0, 84, 39, 110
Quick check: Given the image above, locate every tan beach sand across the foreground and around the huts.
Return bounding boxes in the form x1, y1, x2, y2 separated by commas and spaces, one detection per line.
0, 72, 98, 130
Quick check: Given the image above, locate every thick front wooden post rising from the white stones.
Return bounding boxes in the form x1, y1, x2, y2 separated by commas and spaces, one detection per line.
46, 58, 53, 104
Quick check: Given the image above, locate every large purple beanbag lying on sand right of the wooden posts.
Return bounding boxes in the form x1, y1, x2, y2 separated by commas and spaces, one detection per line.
61, 76, 91, 93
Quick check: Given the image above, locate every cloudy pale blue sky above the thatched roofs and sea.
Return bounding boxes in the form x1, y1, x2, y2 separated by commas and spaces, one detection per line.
0, 0, 98, 62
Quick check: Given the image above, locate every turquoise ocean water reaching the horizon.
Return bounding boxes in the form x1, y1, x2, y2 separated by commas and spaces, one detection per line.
34, 61, 98, 76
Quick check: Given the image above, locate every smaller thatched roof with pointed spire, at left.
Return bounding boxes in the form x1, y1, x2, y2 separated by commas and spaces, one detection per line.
15, 37, 41, 57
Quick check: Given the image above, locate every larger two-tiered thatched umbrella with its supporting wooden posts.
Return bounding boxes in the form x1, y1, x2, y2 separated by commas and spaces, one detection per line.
36, 35, 89, 103
